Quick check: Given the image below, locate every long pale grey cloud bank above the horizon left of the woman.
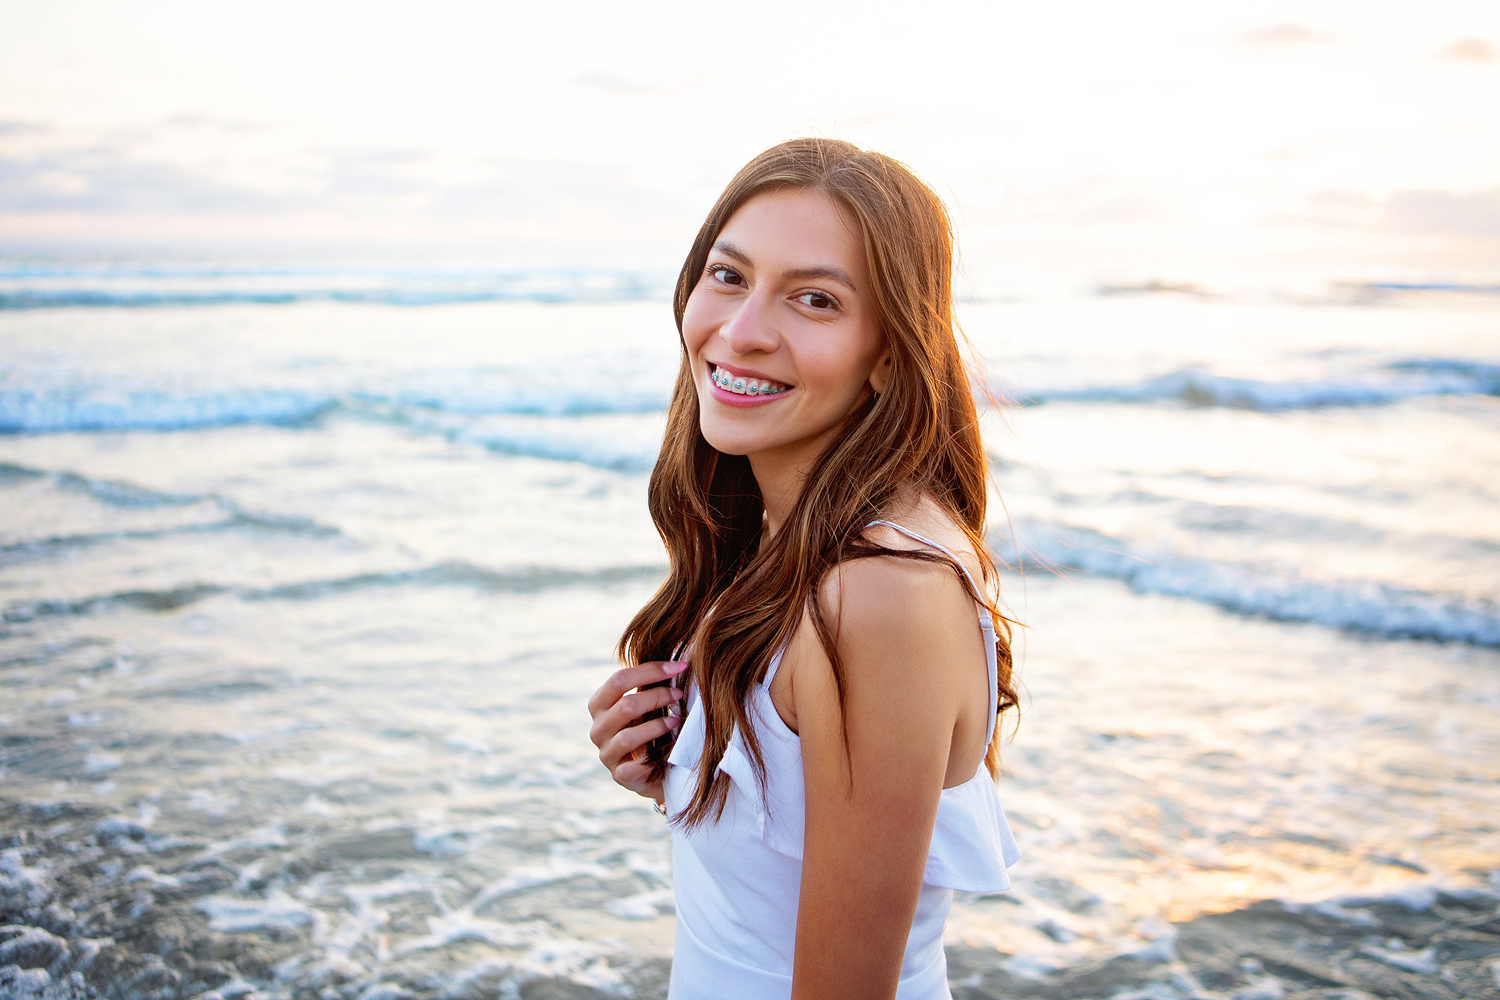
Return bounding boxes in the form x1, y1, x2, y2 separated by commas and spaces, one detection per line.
0, 115, 711, 228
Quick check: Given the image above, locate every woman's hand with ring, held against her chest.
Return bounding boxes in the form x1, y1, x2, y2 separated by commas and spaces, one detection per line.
588, 660, 687, 802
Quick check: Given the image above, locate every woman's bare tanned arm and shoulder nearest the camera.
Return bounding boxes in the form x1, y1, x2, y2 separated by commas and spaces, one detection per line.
788, 558, 984, 1000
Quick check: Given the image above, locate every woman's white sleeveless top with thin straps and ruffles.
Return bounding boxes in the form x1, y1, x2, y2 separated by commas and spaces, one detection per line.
663, 520, 1019, 1000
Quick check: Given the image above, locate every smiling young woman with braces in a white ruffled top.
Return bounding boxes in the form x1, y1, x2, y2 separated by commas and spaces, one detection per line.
590, 139, 1016, 1000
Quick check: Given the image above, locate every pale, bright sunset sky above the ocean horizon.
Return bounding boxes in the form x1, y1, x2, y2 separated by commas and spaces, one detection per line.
0, 0, 1500, 283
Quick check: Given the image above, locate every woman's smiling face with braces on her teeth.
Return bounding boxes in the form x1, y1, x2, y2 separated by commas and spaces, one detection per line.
683, 189, 888, 463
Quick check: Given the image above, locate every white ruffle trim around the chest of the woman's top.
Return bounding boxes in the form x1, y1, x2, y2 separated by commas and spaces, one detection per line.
668, 677, 1020, 892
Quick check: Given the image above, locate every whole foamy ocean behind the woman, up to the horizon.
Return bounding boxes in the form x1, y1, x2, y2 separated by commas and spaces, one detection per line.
0, 258, 1500, 1000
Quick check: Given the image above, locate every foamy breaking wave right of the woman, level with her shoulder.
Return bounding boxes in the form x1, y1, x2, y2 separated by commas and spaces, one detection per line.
996, 520, 1500, 646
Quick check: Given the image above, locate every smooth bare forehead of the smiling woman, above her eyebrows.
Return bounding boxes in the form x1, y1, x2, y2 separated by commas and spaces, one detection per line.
719, 187, 864, 283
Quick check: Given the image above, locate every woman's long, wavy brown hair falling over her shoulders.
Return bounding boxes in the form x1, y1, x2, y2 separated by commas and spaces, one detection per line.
620, 138, 1016, 826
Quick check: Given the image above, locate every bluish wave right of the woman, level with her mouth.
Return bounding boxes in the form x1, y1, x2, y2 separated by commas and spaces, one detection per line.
1026, 358, 1500, 411
